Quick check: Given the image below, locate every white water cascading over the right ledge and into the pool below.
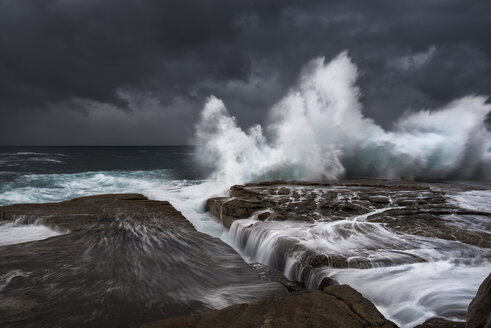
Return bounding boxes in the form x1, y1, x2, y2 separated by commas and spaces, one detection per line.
223, 187, 491, 327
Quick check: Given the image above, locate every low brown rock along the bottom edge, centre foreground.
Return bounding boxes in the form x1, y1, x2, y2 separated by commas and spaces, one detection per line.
141, 285, 397, 328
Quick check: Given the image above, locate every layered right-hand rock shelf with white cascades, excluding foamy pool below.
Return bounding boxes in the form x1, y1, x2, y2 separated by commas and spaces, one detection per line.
207, 180, 491, 327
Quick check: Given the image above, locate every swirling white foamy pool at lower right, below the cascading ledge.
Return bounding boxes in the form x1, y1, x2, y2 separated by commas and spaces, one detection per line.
325, 261, 491, 327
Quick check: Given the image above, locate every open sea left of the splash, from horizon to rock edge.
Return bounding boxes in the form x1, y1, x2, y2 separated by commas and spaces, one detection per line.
0, 146, 224, 234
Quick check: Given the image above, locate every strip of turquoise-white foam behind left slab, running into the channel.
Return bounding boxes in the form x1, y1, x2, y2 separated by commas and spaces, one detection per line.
0, 170, 227, 236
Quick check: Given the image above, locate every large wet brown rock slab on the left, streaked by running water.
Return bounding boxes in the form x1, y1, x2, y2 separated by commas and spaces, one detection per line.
0, 194, 287, 327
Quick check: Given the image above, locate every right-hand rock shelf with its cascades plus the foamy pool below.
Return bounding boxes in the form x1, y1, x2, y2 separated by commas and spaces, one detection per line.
207, 179, 491, 327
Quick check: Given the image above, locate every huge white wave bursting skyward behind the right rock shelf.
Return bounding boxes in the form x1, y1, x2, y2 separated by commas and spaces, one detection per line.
196, 52, 491, 185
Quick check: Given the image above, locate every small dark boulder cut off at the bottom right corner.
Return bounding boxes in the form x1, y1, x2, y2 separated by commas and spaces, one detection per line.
466, 274, 491, 328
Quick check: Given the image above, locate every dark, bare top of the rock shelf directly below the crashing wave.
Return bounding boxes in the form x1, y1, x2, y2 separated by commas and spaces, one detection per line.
207, 180, 491, 249
